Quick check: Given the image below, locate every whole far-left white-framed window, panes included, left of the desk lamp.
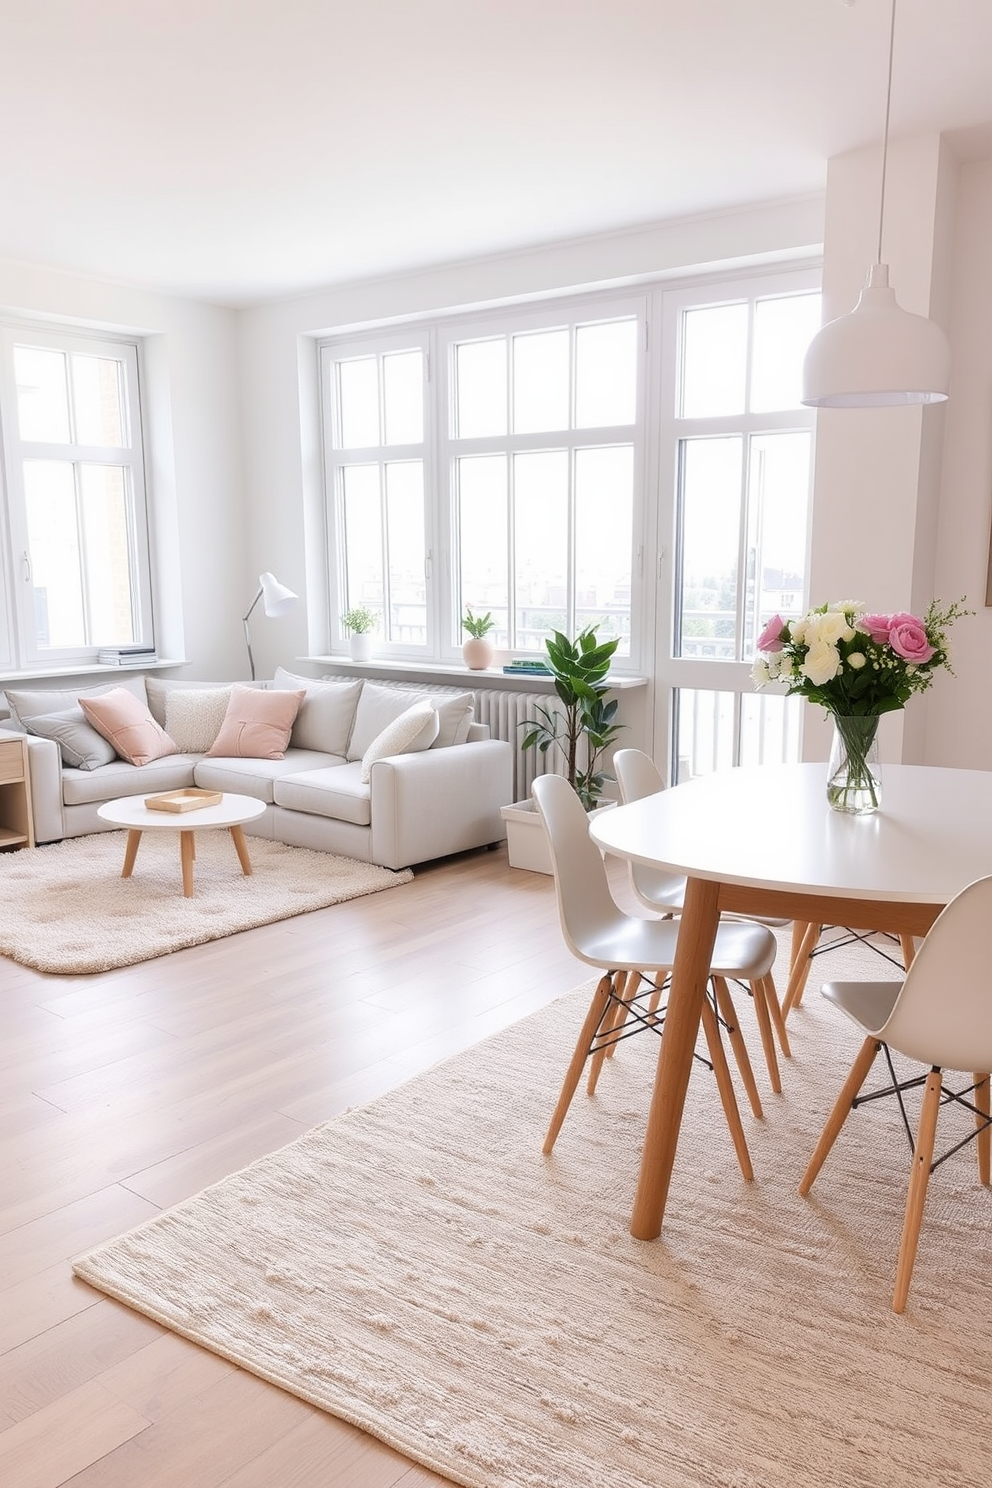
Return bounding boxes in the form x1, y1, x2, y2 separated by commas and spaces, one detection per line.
0, 324, 153, 668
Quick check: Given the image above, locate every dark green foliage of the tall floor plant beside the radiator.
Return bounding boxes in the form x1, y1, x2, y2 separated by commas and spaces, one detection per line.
521, 625, 626, 811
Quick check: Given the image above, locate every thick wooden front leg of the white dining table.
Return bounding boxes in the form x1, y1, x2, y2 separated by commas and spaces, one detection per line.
631, 878, 720, 1240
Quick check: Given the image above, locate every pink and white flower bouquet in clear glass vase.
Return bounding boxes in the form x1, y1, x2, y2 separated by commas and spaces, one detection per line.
751, 600, 971, 814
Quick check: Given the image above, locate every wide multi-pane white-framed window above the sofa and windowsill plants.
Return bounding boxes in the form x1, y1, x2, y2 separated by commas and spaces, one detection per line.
320, 293, 647, 667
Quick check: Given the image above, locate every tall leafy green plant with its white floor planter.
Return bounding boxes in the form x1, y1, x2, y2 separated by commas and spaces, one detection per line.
503, 625, 626, 873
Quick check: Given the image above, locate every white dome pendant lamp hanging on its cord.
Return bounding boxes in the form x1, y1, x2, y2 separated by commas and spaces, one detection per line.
802, 0, 950, 408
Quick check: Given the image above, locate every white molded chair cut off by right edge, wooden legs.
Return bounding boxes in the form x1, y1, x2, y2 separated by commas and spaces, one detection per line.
799, 878, 992, 1312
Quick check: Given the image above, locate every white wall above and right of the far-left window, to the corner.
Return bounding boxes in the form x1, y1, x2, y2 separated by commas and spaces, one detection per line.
0, 260, 246, 679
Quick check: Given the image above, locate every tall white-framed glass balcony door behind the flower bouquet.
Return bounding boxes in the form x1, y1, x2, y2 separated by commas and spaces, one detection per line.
656, 271, 819, 781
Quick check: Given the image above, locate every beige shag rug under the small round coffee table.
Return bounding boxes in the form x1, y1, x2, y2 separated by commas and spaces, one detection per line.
0, 832, 413, 975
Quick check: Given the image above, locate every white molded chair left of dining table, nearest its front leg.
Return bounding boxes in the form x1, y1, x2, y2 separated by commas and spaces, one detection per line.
532, 775, 775, 1178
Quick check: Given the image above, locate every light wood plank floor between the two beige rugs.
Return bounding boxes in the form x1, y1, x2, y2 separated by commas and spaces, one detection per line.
0, 848, 612, 1488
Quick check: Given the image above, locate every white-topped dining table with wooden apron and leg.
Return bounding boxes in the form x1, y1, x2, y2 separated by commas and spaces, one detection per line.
589, 765, 992, 1240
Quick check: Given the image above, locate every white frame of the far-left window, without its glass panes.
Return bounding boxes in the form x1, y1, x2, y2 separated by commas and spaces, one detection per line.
0, 330, 155, 671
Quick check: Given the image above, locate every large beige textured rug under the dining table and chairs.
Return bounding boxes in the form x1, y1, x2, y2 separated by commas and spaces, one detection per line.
74, 952, 992, 1488
